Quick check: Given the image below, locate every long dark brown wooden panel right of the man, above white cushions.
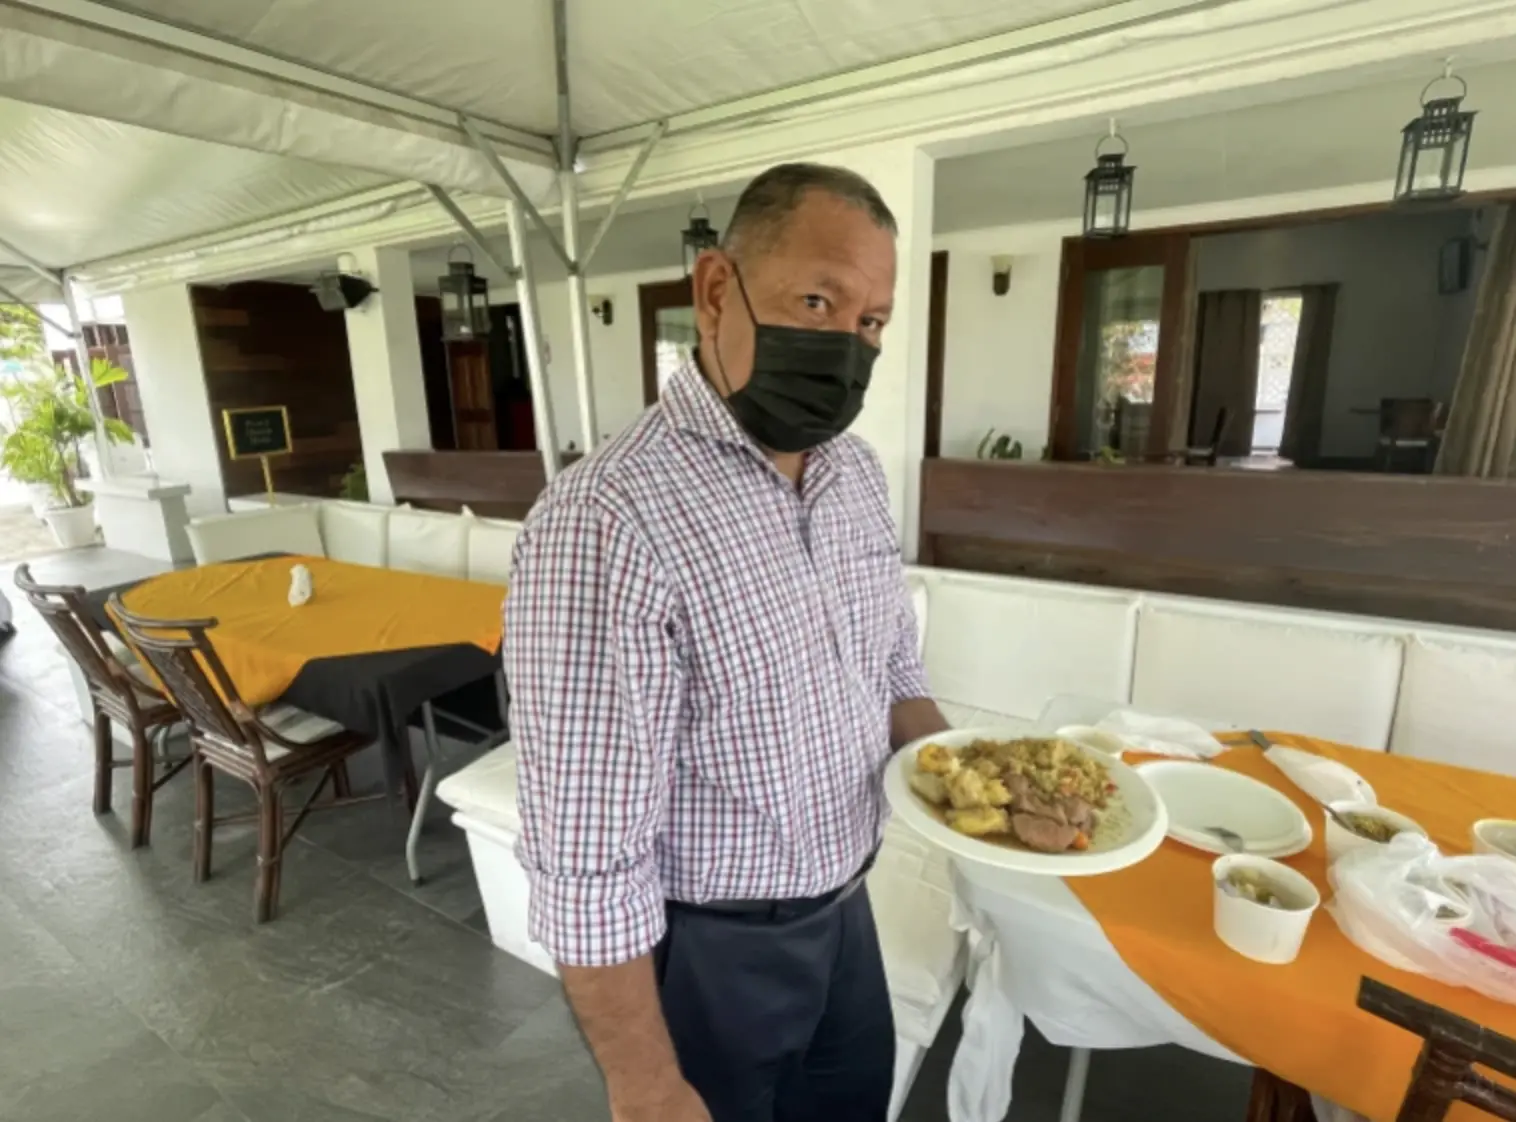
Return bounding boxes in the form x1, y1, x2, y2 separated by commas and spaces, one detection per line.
922, 459, 1516, 629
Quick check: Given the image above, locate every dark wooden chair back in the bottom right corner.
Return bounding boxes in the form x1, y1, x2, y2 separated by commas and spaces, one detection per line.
1358, 978, 1516, 1122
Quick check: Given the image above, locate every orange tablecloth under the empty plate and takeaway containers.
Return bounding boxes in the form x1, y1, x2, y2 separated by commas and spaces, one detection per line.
1066, 734, 1516, 1122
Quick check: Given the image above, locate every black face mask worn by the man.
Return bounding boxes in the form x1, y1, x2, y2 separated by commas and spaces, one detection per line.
717, 270, 879, 452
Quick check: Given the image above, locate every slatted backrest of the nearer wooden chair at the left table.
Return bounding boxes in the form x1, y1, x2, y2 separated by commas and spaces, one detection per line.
111, 593, 268, 767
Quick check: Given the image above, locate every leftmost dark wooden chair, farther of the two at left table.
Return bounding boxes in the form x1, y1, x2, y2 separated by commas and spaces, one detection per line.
15, 564, 190, 849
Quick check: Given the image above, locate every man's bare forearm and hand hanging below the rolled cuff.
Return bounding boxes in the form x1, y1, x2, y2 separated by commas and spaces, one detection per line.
558, 955, 711, 1122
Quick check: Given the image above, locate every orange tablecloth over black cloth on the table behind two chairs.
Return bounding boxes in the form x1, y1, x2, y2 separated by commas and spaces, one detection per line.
121, 556, 505, 705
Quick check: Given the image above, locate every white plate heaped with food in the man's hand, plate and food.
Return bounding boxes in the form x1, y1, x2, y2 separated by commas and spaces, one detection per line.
884, 728, 1169, 876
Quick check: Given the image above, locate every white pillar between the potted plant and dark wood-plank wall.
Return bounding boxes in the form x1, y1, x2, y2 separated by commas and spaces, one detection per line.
121, 285, 226, 514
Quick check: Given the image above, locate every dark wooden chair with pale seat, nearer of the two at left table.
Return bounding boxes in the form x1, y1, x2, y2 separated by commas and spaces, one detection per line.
111, 596, 385, 923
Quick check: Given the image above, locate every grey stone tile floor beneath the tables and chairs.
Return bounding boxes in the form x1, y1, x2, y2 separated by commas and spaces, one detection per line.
0, 549, 1248, 1122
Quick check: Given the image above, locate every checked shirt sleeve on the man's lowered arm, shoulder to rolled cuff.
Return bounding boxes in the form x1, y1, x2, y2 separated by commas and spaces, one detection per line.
505, 499, 682, 966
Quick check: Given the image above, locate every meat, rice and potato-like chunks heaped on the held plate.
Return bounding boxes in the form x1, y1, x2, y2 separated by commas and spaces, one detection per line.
910, 737, 1116, 854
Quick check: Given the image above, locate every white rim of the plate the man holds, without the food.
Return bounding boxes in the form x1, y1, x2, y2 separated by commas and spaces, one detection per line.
884, 728, 1169, 876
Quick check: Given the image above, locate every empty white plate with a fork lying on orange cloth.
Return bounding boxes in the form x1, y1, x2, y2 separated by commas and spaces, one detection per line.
1137, 760, 1311, 858
